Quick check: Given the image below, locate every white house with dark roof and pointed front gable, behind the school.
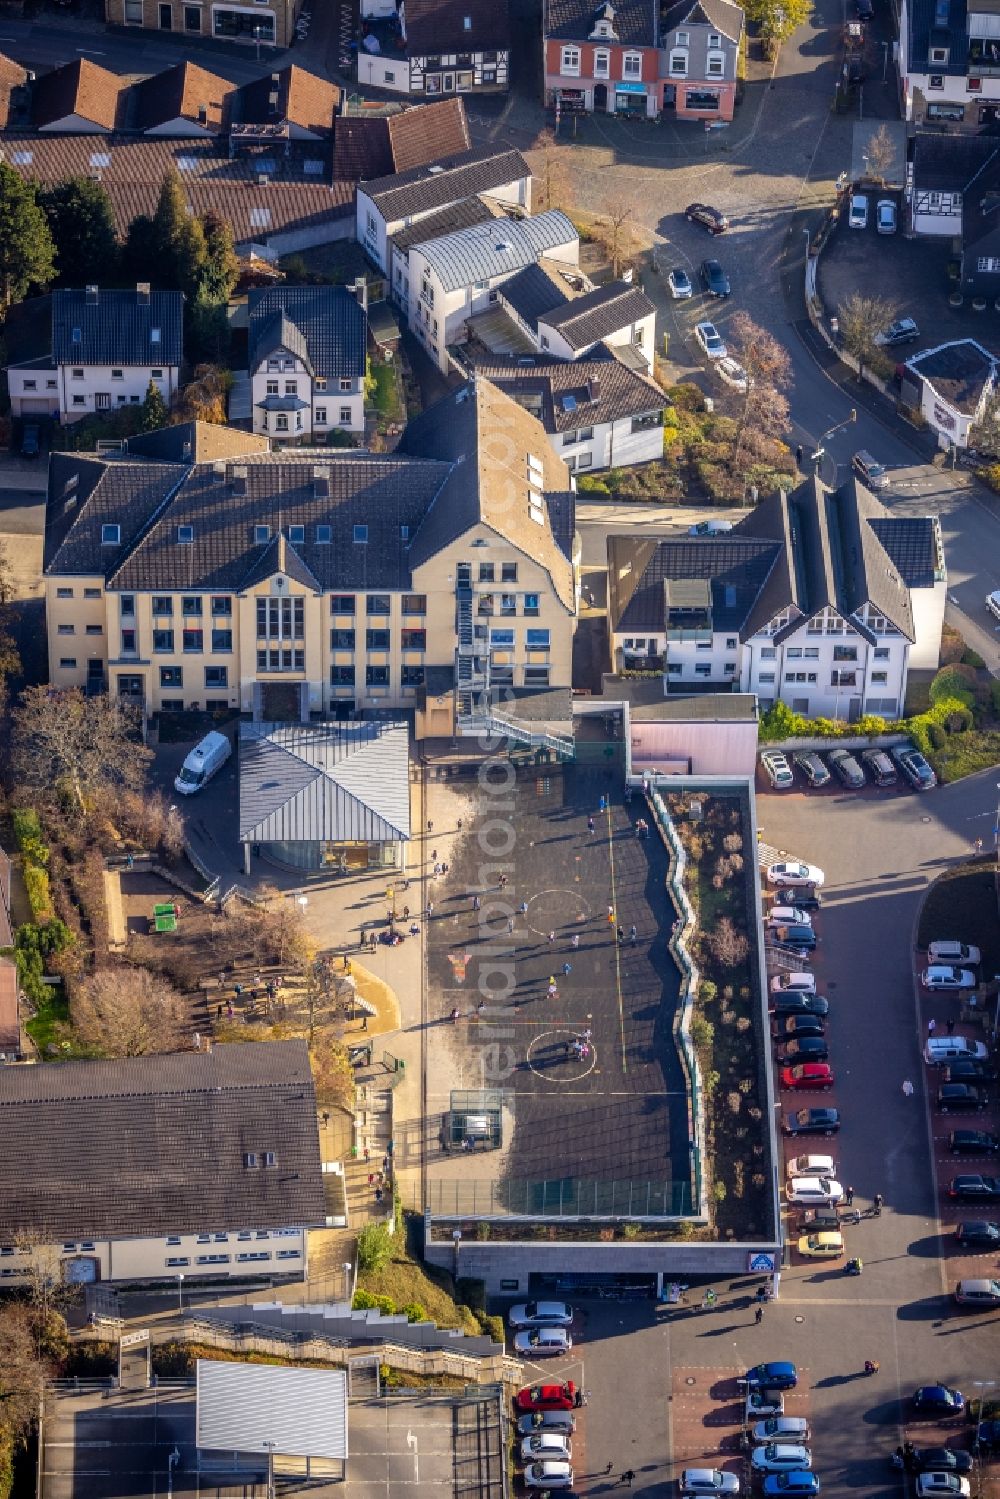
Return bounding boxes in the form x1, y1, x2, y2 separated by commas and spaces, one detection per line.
247, 286, 367, 444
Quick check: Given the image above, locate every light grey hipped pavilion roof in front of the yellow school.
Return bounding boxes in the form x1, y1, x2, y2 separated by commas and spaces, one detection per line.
240, 723, 409, 842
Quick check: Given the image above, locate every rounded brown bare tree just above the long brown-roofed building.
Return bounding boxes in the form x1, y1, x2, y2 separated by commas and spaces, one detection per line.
69, 967, 189, 1057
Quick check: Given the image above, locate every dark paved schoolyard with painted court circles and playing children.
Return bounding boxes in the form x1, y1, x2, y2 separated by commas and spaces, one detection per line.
424, 745, 691, 1217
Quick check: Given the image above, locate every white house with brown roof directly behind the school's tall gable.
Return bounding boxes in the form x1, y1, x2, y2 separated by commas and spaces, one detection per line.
477, 345, 666, 474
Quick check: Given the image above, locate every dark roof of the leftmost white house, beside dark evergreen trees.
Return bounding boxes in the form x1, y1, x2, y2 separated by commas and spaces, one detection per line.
52, 286, 184, 366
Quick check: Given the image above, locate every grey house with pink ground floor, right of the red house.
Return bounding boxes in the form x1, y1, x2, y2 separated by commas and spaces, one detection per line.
660, 0, 744, 120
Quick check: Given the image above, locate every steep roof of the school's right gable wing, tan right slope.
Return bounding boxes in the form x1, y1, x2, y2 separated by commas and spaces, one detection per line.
396, 376, 574, 610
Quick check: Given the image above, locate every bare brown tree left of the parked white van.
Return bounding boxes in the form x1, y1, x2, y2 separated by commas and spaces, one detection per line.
13, 687, 151, 811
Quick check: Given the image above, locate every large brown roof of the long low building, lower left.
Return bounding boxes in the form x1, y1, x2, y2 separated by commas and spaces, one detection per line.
0, 1040, 325, 1243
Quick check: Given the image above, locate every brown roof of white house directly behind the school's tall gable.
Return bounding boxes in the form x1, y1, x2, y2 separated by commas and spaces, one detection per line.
477, 346, 667, 433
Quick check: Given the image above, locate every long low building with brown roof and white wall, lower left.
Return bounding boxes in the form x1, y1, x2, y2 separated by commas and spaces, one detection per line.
0, 1040, 327, 1285
